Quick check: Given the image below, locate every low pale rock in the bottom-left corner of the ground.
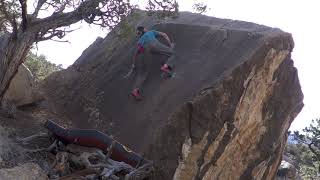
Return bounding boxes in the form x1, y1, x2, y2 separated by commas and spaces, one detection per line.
0, 163, 48, 180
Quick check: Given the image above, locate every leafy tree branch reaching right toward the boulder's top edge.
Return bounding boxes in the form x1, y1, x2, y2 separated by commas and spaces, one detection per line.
30, 0, 131, 42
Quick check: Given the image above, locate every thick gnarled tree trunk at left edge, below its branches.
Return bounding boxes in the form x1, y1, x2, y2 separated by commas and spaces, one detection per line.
0, 31, 35, 104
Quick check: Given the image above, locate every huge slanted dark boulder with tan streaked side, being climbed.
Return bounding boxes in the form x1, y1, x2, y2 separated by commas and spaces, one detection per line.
45, 12, 303, 180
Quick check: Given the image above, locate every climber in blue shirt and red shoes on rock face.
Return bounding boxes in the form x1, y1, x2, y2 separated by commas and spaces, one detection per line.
131, 26, 174, 100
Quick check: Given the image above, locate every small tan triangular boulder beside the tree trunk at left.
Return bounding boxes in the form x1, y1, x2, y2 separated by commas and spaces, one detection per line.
4, 64, 41, 106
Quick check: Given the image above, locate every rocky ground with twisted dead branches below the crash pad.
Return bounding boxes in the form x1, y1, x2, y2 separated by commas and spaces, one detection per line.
0, 104, 153, 180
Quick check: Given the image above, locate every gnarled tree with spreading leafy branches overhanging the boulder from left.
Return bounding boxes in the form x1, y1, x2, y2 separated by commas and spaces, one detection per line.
0, 0, 178, 106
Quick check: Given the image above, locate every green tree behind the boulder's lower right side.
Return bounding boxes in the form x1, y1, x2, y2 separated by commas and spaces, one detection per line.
294, 119, 320, 175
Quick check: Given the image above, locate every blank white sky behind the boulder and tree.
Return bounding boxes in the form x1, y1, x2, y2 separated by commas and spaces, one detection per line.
30, 0, 320, 130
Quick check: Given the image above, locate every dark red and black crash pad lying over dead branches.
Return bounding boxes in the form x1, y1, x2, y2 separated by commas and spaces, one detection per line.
45, 120, 152, 168
